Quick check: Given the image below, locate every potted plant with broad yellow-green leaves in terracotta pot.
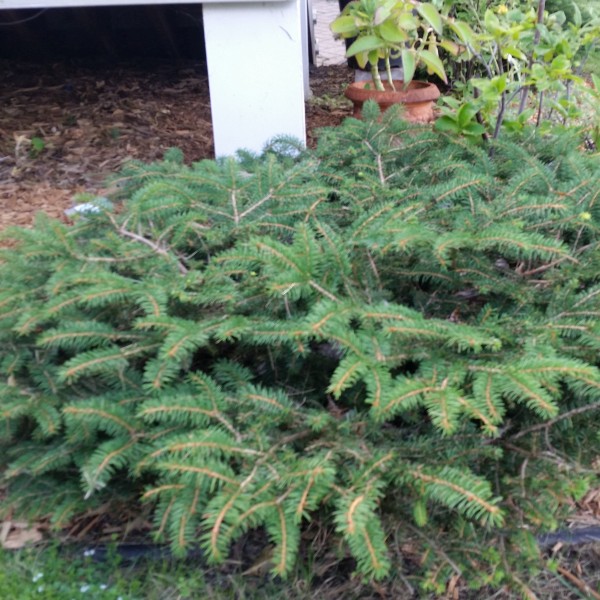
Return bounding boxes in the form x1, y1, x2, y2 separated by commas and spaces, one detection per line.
331, 0, 474, 122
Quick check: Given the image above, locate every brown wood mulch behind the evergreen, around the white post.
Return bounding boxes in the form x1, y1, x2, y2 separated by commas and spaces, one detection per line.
0, 60, 352, 229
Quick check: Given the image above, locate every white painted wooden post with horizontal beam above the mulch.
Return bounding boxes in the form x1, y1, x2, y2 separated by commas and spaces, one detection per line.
0, 0, 309, 156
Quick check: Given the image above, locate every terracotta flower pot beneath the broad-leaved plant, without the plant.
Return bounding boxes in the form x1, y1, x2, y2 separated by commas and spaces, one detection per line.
345, 80, 440, 123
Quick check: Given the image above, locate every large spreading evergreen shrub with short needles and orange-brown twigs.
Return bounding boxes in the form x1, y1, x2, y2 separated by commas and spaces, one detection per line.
0, 106, 600, 589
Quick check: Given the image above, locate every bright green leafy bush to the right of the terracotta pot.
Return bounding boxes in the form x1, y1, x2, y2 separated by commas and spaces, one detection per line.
436, 0, 600, 140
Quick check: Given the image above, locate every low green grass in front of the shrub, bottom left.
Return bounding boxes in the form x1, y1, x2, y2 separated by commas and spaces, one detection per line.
0, 544, 338, 600
